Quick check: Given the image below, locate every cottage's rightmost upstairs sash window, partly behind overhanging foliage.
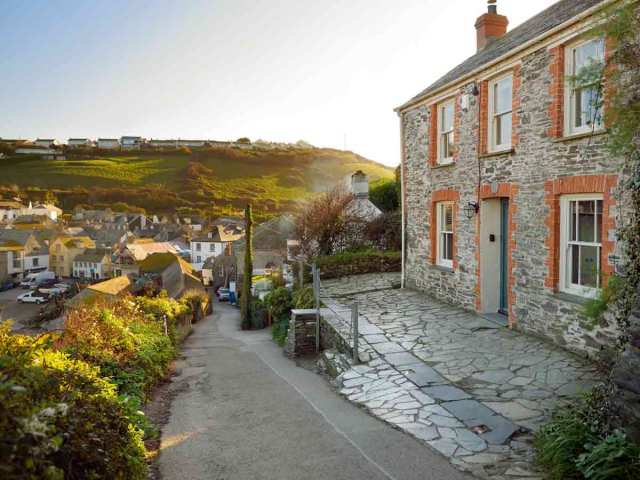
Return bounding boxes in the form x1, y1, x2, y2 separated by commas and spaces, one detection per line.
565, 38, 604, 134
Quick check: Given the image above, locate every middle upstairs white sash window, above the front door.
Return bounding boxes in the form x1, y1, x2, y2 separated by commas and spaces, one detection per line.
489, 75, 513, 152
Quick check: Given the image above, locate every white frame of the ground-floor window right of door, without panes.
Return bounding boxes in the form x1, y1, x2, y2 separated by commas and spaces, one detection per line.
558, 193, 606, 298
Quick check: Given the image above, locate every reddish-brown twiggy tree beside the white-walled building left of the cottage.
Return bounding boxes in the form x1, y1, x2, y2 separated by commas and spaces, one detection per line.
296, 187, 360, 257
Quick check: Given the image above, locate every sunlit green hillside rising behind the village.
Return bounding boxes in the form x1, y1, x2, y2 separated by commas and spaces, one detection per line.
0, 146, 393, 218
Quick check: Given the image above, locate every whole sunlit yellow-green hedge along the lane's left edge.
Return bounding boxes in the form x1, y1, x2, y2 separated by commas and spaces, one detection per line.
0, 297, 191, 480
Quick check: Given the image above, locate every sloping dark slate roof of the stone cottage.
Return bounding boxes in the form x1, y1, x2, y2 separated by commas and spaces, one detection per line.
398, 0, 604, 110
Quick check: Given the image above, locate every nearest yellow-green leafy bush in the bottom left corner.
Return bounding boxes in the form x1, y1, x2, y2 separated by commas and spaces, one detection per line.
0, 323, 147, 480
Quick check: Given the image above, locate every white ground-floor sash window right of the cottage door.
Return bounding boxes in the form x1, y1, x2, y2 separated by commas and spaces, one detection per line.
560, 194, 602, 297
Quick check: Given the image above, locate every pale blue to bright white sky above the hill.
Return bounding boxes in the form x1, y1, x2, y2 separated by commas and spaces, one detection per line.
0, 0, 555, 166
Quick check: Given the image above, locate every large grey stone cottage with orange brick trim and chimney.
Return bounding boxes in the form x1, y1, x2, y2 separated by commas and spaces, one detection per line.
396, 0, 623, 353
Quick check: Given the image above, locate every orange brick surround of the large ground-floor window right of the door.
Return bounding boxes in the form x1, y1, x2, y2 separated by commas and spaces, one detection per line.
544, 175, 618, 291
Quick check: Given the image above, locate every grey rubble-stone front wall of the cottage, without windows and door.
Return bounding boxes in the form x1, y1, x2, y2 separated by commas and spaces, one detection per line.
401, 41, 623, 354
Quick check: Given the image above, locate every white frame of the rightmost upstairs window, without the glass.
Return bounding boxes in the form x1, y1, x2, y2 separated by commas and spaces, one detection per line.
563, 37, 606, 136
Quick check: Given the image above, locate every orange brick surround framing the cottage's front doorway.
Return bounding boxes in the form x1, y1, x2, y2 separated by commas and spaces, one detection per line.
476, 183, 518, 327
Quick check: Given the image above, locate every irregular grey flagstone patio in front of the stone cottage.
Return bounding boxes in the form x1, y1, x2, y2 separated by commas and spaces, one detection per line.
322, 274, 598, 480
